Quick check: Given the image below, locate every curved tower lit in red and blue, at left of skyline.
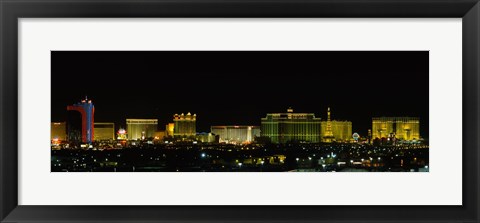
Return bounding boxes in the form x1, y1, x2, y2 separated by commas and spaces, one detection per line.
67, 97, 95, 143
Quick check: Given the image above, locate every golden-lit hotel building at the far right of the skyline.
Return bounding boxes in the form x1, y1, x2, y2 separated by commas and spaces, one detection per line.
372, 117, 420, 141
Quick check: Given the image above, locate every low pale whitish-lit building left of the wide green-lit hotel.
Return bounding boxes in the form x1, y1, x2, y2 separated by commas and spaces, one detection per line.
210, 125, 260, 144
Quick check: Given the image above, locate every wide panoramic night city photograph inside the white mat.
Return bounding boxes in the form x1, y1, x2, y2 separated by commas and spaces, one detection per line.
50, 51, 430, 172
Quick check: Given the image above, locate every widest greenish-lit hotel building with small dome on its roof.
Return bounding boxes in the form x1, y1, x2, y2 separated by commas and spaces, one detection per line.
260, 108, 320, 143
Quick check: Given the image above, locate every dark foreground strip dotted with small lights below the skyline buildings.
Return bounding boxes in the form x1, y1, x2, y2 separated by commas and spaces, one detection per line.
51, 144, 429, 172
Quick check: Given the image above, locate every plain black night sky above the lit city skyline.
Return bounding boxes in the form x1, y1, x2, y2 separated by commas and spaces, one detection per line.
51, 51, 429, 137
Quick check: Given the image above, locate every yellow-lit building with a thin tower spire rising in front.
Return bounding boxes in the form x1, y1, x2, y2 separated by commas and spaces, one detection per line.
321, 108, 352, 143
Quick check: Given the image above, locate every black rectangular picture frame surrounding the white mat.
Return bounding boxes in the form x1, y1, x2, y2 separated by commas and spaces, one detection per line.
0, 0, 480, 223
